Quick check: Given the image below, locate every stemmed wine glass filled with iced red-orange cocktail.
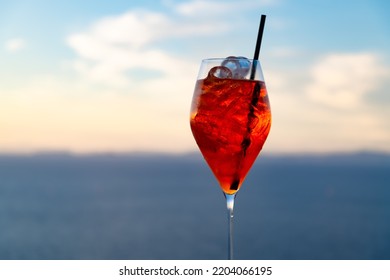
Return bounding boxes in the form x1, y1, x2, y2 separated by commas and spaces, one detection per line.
190, 57, 271, 259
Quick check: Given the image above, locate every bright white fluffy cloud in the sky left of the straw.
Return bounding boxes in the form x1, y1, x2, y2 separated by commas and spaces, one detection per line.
66, 7, 232, 87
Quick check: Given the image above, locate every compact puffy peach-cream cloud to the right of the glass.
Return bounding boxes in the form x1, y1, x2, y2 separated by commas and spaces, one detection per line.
306, 53, 388, 109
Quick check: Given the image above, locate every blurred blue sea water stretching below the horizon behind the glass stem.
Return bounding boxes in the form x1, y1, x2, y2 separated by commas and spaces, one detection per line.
0, 153, 390, 260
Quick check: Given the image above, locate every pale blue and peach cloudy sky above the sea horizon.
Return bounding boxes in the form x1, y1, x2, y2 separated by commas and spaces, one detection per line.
0, 0, 390, 153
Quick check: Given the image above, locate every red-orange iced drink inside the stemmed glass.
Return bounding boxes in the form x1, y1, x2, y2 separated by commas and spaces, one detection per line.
191, 78, 271, 194
